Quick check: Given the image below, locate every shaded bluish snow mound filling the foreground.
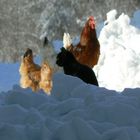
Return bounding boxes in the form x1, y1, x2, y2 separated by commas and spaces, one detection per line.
0, 73, 140, 140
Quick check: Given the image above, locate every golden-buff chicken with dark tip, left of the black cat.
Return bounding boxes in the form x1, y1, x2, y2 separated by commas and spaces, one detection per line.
19, 49, 53, 95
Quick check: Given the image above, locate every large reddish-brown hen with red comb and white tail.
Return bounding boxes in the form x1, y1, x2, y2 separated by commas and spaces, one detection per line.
63, 16, 100, 68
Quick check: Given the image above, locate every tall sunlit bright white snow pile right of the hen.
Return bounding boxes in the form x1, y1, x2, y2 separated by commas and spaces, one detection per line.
95, 10, 140, 91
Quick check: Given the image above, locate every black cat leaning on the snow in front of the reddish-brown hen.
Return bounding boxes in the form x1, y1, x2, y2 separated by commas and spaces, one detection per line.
56, 47, 99, 86
